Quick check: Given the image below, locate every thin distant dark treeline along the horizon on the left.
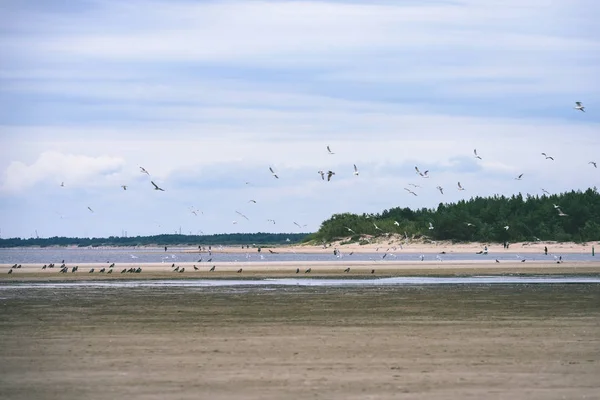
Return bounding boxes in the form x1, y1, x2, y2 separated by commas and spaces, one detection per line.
0, 232, 307, 247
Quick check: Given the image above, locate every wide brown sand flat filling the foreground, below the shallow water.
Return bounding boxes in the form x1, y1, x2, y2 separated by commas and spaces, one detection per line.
0, 284, 600, 400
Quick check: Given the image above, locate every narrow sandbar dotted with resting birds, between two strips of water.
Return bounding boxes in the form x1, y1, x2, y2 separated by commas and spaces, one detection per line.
0, 260, 600, 284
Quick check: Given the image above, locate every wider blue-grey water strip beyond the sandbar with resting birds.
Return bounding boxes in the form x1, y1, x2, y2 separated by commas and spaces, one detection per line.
0, 248, 600, 264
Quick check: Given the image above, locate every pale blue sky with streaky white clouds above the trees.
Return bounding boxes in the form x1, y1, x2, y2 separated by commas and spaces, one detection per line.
0, 0, 600, 238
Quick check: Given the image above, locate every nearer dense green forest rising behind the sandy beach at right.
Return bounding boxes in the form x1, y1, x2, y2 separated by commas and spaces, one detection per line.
305, 187, 600, 243
